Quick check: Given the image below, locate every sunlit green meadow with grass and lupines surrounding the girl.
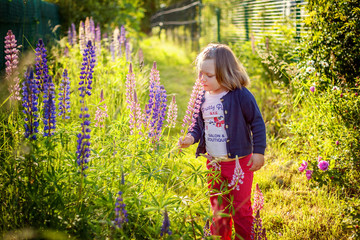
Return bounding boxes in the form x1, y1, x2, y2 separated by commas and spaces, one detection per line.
0, 13, 359, 239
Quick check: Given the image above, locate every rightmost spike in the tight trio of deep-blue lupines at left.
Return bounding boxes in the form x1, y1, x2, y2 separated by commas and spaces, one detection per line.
43, 77, 56, 137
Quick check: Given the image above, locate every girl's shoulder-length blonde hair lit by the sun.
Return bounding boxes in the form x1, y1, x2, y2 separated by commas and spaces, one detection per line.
196, 44, 250, 91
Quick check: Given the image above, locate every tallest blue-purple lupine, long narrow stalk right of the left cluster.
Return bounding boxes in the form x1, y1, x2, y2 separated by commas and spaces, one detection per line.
76, 41, 95, 176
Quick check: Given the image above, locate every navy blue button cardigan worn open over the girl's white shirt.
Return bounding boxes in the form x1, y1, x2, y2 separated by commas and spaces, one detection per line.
189, 87, 266, 158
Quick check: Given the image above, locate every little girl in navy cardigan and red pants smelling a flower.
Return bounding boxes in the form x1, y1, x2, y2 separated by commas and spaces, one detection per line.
179, 44, 266, 240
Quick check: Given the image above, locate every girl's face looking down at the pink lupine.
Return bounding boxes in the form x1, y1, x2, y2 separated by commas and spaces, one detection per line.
199, 59, 225, 94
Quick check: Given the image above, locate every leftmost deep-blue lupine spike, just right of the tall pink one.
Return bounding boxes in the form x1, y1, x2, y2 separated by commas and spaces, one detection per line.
22, 67, 39, 140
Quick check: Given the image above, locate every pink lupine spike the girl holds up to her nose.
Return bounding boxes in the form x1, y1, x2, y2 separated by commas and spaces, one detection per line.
181, 75, 204, 133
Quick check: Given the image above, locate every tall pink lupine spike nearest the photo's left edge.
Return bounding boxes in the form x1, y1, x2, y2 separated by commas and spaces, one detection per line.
5, 30, 21, 100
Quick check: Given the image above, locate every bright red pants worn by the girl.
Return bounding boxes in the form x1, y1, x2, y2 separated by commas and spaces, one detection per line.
207, 154, 254, 240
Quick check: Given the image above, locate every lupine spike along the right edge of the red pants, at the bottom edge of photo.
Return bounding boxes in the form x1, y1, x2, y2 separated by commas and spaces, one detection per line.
251, 184, 267, 240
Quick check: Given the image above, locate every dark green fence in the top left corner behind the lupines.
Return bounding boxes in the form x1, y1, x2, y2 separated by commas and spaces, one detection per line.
0, 0, 60, 73
